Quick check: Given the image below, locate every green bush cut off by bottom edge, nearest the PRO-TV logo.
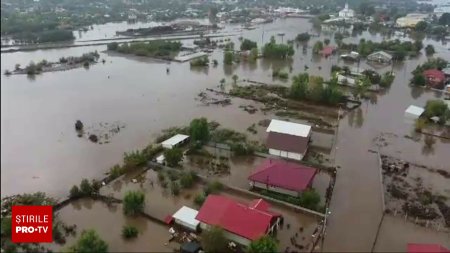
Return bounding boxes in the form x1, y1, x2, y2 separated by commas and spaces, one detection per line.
69, 230, 108, 253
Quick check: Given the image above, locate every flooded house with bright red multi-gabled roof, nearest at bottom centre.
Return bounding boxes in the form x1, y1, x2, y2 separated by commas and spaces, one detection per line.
195, 194, 281, 246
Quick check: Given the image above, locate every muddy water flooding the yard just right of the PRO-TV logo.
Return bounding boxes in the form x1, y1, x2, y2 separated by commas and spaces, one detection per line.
51, 199, 179, 252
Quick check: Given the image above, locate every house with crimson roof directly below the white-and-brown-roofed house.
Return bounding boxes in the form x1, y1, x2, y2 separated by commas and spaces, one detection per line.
248, 159, 317, 197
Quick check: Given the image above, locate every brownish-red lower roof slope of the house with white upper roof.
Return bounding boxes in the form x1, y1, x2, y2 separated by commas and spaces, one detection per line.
266, 132, 309, 154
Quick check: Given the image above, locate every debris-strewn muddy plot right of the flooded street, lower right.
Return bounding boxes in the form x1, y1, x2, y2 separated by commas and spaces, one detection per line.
381, 156, 450, 231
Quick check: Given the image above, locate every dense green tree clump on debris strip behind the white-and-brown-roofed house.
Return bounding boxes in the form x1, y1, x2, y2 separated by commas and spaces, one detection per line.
290, 73, 344, 105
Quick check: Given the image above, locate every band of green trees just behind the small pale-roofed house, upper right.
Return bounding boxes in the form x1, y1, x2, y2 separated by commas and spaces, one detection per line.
339, 39, 423, 61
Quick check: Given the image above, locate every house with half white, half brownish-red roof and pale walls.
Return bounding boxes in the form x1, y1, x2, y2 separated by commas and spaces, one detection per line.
266, 119, 311, 161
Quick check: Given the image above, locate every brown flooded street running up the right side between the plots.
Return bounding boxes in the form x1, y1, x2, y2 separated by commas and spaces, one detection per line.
322, 52, 449, 252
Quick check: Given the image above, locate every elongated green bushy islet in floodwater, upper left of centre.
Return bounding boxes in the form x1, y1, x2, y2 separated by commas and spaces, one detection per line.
108, 40, 181, 59
